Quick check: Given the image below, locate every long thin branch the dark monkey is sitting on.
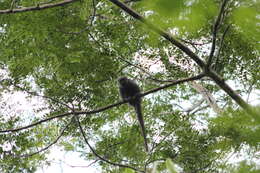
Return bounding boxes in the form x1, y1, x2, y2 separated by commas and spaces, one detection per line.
0, 74, 204, 133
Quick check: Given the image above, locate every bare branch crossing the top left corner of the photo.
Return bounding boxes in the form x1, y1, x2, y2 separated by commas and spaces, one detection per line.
0, 0, 79, 14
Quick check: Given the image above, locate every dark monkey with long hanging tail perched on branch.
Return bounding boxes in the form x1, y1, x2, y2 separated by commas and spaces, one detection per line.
118, 77, 149, 152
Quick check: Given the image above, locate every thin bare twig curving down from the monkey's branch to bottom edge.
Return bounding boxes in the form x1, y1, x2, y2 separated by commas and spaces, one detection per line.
76, 117, 144, 172
